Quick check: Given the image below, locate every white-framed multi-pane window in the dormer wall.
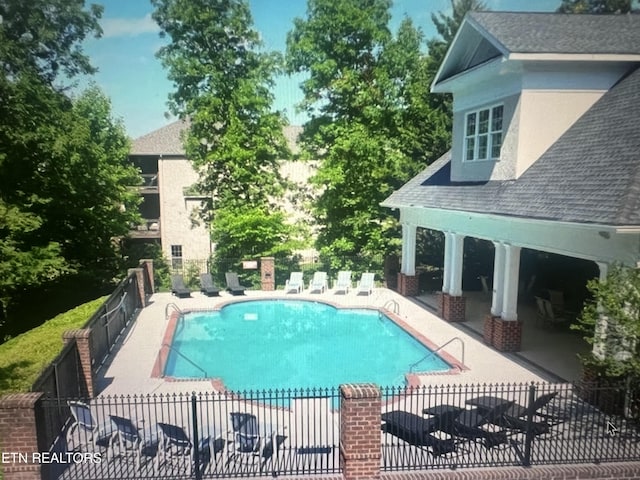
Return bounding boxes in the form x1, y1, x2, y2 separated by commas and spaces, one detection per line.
464, 105, 504, 161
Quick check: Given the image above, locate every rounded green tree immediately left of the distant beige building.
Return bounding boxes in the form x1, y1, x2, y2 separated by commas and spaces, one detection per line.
41, 85, 141, 272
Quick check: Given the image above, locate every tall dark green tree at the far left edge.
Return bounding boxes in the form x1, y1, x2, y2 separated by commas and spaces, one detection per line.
0, 0, 102, 322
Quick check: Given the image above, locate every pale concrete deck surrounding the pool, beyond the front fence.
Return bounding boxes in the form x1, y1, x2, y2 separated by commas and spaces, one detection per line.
97, 288, 576, 395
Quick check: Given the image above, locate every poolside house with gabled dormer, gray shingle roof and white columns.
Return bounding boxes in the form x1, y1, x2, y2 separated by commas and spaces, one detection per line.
383, 12, 640, 350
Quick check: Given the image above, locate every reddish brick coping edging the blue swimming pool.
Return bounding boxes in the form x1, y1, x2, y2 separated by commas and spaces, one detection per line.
150, 296, 469, 392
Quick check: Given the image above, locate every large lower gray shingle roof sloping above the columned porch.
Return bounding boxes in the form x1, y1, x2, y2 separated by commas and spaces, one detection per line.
383, 64, 640, 226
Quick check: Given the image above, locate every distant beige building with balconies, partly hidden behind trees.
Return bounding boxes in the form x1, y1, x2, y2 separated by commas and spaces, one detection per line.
129, 121, 312, 270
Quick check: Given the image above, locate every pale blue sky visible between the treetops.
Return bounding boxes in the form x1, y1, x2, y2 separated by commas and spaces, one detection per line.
84, 0, 561, 138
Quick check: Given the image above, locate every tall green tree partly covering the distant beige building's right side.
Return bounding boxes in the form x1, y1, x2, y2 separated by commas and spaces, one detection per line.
152, 0, 287, 216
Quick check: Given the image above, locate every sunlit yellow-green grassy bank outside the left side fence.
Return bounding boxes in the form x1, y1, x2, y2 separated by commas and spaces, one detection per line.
0, 297, 106, 396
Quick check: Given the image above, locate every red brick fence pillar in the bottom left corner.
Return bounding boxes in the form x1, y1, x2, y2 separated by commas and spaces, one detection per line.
0, 392, 46, 480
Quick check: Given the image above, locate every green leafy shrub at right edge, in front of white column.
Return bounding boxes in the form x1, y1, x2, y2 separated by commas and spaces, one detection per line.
573, 265, 640, 379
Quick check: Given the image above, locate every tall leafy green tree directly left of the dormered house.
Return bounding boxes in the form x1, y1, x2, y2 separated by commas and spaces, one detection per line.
287, 0, 477, 263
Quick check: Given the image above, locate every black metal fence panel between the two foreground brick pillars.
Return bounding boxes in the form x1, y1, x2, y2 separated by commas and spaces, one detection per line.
43, 389, 340, 479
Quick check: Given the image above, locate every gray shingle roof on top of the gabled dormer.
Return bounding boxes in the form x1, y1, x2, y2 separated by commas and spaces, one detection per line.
467, 12, 640, 54
